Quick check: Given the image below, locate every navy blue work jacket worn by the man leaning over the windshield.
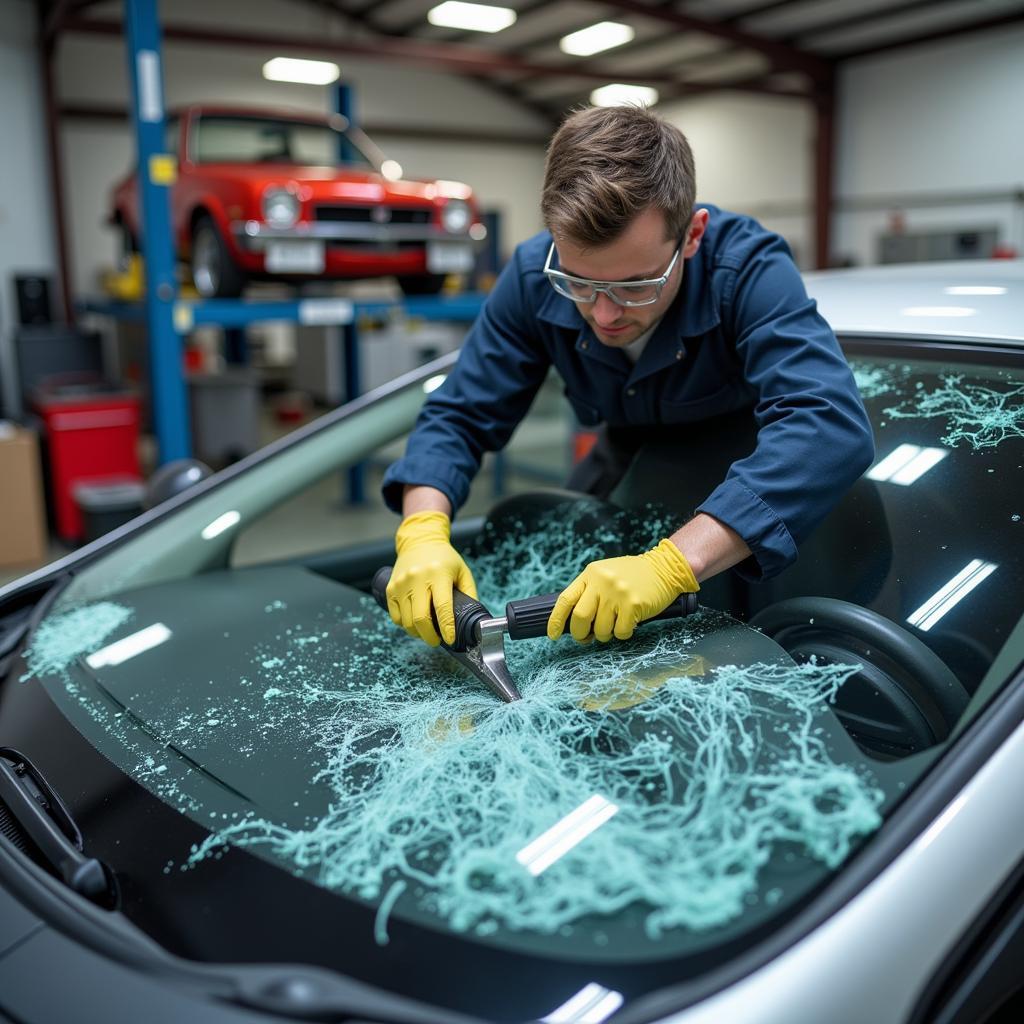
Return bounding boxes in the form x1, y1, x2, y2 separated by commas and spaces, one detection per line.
383, 204, 874, 580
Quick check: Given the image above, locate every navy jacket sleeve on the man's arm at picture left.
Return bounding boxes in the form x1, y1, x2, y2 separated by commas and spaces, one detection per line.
382, 250, 550, 512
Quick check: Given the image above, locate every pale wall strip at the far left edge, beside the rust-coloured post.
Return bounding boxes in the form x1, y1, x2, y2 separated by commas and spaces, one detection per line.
0, 0, 59, 319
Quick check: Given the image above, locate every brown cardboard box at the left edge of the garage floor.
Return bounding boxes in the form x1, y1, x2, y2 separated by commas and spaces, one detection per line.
0, 421, 47, 567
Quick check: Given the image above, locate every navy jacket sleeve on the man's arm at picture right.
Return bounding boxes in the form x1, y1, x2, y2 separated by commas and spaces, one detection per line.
697, 234, 874, 581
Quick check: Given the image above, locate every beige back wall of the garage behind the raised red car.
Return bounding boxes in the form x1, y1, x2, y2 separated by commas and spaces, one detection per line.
57, 0, 549, 293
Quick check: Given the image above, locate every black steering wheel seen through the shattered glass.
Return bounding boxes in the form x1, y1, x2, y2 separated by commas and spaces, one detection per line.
748, 597, 970, 758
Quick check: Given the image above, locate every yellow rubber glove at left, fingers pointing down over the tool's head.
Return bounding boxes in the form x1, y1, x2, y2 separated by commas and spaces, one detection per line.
387, 512, 476, 647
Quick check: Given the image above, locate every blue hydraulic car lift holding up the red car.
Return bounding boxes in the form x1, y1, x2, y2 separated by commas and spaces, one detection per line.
110, 0, 483, 502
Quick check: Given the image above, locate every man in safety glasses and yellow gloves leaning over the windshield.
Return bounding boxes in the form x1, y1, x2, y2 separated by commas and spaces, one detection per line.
383, 106, 873, 645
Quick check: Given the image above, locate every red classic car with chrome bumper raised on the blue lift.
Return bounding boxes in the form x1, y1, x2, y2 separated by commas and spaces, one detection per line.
110, 105, 485, 297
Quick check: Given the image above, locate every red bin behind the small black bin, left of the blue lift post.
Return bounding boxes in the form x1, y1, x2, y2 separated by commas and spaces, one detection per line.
35, 388, 141, 541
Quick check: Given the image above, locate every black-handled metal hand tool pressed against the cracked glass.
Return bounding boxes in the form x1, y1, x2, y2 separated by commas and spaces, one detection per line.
372, 565, 698, 703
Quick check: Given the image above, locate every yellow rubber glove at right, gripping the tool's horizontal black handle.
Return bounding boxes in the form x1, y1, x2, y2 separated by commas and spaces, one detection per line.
548, 540, 700, 643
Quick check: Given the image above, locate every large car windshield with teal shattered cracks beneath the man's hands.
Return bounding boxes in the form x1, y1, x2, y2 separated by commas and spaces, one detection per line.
8, 346, 1024, 1019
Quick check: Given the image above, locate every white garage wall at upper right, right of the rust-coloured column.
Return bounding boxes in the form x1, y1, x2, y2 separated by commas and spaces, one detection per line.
834, 28, 1024, 263
